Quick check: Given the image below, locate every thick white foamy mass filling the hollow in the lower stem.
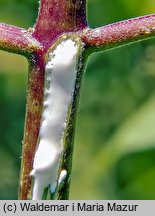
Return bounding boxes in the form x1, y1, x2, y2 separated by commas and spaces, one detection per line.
31, 38, 78, 200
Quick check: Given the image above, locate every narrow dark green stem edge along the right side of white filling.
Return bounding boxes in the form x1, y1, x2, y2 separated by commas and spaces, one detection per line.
55, 48, 87, 200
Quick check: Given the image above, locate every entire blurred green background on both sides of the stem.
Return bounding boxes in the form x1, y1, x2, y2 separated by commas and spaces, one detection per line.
0, 0, 155, 199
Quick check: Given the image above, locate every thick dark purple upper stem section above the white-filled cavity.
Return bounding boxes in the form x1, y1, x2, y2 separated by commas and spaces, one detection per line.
33, 0, 87, 50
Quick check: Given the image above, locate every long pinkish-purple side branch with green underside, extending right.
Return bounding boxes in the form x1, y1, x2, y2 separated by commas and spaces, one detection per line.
81, 14, 155, 51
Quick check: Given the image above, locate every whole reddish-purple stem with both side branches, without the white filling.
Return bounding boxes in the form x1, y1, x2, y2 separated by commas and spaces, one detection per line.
0, 0, 155, 199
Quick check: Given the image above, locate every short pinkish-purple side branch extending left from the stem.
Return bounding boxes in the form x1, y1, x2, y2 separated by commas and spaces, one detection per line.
0, 23, 41, 55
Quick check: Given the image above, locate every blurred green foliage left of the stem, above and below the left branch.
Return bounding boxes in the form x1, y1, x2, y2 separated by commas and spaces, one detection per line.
0, 0, 32, 199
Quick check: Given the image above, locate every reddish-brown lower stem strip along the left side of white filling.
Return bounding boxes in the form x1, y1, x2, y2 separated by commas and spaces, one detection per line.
19, 55, 44, 200
